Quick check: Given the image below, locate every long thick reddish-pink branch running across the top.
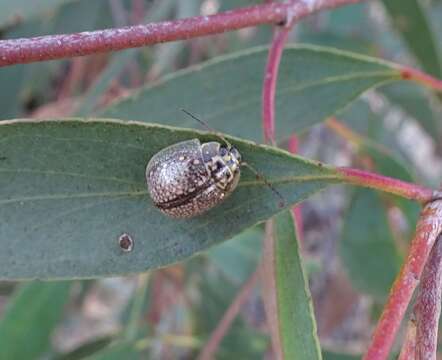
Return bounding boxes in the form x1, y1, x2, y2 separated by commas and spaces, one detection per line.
0, 0, 362, 66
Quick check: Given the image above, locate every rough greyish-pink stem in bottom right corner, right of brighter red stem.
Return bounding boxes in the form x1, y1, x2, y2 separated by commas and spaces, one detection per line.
414, 236, 442, 360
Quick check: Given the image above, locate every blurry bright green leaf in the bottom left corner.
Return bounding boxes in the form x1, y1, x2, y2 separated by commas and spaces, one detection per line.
0, 281, 71, 360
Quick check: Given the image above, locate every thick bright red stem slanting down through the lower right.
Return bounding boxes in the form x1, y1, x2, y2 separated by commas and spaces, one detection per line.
364, 200, 442, 360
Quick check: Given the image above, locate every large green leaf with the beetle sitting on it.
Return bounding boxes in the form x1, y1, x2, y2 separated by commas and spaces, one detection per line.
0, 119, 340, 279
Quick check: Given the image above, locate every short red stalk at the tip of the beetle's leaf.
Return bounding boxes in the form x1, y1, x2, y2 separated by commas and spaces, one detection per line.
338, 167, 440, 204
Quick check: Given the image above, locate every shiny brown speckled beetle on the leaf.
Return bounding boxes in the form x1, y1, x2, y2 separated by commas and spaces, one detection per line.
146, 139, 241, 218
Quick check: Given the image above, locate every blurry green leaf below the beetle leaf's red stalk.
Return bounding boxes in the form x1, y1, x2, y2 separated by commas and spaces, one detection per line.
340, 189, 401, 300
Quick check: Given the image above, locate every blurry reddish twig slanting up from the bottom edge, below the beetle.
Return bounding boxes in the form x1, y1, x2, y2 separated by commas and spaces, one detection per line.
198, 266, 260, 360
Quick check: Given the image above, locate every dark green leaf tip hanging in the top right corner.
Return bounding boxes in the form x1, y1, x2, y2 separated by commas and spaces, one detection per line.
383, 0, 442, 77
